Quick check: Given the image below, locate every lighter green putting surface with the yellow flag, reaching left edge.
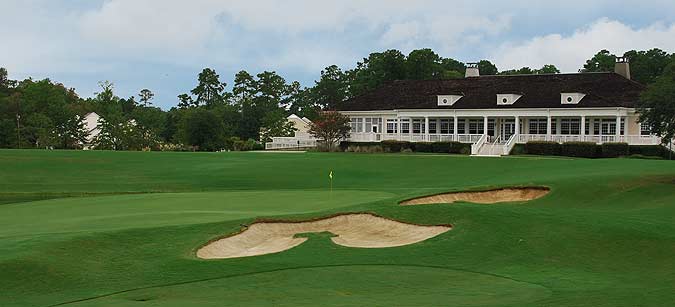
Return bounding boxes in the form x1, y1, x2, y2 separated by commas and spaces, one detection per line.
0, 190, 393, 238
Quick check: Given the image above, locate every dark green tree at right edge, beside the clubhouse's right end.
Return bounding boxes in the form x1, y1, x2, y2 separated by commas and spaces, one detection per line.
637, 61, 675, 144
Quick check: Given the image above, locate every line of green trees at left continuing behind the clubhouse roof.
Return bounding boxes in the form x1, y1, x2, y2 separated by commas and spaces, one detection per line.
0, 49, 674, 151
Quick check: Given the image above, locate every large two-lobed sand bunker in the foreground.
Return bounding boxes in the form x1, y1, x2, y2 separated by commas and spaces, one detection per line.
197, 214, 452, 259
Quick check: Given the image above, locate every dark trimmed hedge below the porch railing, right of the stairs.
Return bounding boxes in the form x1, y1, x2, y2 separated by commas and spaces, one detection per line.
519, 141, 667, 158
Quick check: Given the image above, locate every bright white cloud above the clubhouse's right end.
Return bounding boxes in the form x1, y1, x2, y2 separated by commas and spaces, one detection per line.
492, 18, 675, 72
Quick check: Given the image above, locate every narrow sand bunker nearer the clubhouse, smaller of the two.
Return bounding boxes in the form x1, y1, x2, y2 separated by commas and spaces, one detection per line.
401, 187, 550, 206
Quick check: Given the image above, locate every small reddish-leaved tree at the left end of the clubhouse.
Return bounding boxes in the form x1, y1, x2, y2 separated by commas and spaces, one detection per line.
309, 111, 351, 151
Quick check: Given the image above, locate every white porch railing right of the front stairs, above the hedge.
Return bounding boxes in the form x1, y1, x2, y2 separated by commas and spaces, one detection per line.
516, 134, 661, 145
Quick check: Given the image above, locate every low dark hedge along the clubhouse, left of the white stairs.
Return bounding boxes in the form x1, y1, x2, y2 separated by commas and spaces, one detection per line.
340, 141, 471, 155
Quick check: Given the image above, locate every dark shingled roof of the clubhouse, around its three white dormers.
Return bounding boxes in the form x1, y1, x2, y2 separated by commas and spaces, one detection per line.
336, 73, 645, 111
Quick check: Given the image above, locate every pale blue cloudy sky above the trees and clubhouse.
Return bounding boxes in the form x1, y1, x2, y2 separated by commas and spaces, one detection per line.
0, 0, 675, 109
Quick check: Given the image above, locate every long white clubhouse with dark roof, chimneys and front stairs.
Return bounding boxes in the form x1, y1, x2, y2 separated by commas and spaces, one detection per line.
337, 59, 661, 155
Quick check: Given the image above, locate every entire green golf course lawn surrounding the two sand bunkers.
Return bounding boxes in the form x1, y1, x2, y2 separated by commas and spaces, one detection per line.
0, 151, 675, 306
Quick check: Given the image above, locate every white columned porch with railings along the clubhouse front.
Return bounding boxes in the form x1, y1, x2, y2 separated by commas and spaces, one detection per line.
350, 109, 661, 154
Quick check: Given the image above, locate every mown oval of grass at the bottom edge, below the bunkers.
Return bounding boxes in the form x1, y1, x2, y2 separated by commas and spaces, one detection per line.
68, 265, 551, 307
